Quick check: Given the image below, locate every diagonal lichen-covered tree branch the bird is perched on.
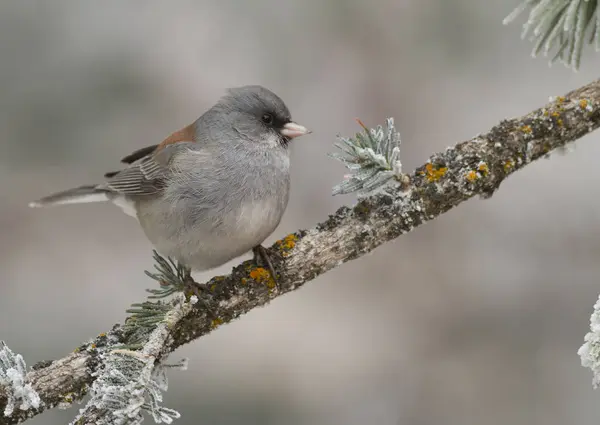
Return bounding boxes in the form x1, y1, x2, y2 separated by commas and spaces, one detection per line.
0, 80, 600, 425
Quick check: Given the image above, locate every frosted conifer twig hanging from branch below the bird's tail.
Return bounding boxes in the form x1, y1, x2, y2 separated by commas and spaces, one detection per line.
71, 255, 198, 425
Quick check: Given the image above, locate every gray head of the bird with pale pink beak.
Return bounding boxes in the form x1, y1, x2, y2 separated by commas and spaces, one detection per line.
205, 86, 310, 147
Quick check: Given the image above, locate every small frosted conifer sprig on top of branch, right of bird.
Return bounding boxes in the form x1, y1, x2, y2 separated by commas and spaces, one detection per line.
329, 118, 403, 195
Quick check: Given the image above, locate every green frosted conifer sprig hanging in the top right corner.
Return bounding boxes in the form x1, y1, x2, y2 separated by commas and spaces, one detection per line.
503, 0, 600, 70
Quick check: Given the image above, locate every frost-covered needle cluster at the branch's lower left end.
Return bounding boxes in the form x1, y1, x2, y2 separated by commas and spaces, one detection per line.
0, 341, 41, 416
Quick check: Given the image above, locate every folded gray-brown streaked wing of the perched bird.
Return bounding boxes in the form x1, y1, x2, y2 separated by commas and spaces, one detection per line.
102, 142, 193, 196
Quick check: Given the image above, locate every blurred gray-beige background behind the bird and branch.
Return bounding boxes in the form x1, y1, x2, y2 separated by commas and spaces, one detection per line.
0, 0, 600, 425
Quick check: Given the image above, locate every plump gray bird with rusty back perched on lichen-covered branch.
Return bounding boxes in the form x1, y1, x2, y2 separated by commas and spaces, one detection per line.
29, 85, 311, 283
